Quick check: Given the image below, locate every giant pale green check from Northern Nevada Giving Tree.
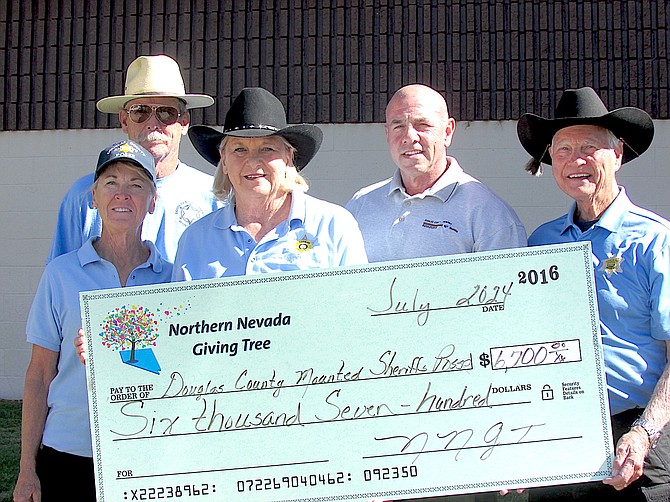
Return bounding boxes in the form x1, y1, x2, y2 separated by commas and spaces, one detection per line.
81, 243, 613, 502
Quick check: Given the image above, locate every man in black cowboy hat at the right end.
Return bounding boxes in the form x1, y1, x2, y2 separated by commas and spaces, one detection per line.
517, 87, 670, 501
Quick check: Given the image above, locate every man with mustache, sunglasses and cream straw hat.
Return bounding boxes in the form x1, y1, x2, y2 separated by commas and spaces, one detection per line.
47, 55, 220, 261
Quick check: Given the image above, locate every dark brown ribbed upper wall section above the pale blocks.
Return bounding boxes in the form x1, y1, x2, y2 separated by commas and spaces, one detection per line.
0, 0, 670, 130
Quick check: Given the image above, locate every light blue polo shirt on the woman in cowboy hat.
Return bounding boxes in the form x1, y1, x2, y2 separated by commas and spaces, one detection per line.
172, 191, 367, 281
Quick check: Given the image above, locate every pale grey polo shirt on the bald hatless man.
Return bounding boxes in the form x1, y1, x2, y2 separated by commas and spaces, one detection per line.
346, 157, 526, 262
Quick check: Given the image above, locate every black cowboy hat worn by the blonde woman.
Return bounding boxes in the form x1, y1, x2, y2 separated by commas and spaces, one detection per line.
188, 87, 323, 171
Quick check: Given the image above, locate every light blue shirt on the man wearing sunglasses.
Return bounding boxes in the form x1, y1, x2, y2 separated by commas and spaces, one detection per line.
47, 162, 222, 263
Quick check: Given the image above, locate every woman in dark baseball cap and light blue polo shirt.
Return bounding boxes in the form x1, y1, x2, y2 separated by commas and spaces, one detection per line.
14, 141, 172, 502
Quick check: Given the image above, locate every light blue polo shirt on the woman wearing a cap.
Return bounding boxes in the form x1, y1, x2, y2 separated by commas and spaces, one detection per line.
26, 237, 172, 457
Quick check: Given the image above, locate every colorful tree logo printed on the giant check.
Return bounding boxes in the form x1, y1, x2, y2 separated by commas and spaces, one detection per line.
100, 305, 158, 363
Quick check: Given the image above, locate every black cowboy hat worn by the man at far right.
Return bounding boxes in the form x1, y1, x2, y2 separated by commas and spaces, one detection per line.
516, 87, 654, 168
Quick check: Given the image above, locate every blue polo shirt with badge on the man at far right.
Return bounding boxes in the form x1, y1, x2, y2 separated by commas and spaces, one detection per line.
528, 187, 670, 415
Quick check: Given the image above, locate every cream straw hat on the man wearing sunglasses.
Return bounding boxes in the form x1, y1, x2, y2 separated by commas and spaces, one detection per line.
96, 55, 214, 113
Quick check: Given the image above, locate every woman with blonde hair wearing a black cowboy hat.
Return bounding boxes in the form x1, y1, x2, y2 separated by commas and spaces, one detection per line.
168, 88, 367, 281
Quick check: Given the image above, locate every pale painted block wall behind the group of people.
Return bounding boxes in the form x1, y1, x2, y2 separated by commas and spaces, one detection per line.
0, 121, 670, 399
